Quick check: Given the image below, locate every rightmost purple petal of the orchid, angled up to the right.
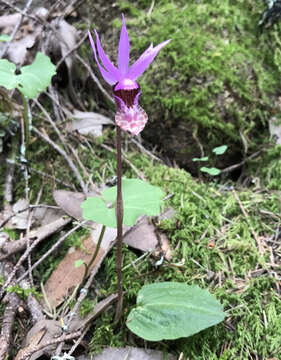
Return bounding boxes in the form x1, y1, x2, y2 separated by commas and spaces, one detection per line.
127, 40, 171, 80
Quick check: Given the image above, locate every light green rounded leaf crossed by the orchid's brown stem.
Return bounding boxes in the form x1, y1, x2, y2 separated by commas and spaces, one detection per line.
82, 179, 164, 227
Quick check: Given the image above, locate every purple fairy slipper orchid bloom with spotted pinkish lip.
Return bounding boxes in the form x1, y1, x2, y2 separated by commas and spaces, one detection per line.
89, 15, 170, 135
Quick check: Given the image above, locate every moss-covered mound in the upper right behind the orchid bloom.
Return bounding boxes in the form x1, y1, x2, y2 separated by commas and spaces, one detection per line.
113, 0, 281, 168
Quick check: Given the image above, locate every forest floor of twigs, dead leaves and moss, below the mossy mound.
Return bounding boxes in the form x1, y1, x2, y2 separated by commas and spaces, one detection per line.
0, 0, 281, 360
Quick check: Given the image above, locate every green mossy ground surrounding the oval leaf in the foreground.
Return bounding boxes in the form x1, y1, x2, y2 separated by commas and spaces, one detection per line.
2, 117, 281, 360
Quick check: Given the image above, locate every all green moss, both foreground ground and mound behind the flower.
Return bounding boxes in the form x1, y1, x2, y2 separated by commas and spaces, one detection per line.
0, 0, 281, 360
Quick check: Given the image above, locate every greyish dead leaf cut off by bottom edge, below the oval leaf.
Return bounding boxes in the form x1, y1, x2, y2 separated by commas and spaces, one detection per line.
82, 346, 176, 360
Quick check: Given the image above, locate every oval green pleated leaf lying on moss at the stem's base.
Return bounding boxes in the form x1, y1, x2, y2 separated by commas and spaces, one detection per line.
126, 282, 225, 341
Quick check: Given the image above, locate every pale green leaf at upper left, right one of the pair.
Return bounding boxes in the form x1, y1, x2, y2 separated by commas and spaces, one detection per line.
17, 52, 56, 99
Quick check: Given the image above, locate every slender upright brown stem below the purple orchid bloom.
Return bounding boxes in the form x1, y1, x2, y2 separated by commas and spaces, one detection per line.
115, 126, 123, 322
